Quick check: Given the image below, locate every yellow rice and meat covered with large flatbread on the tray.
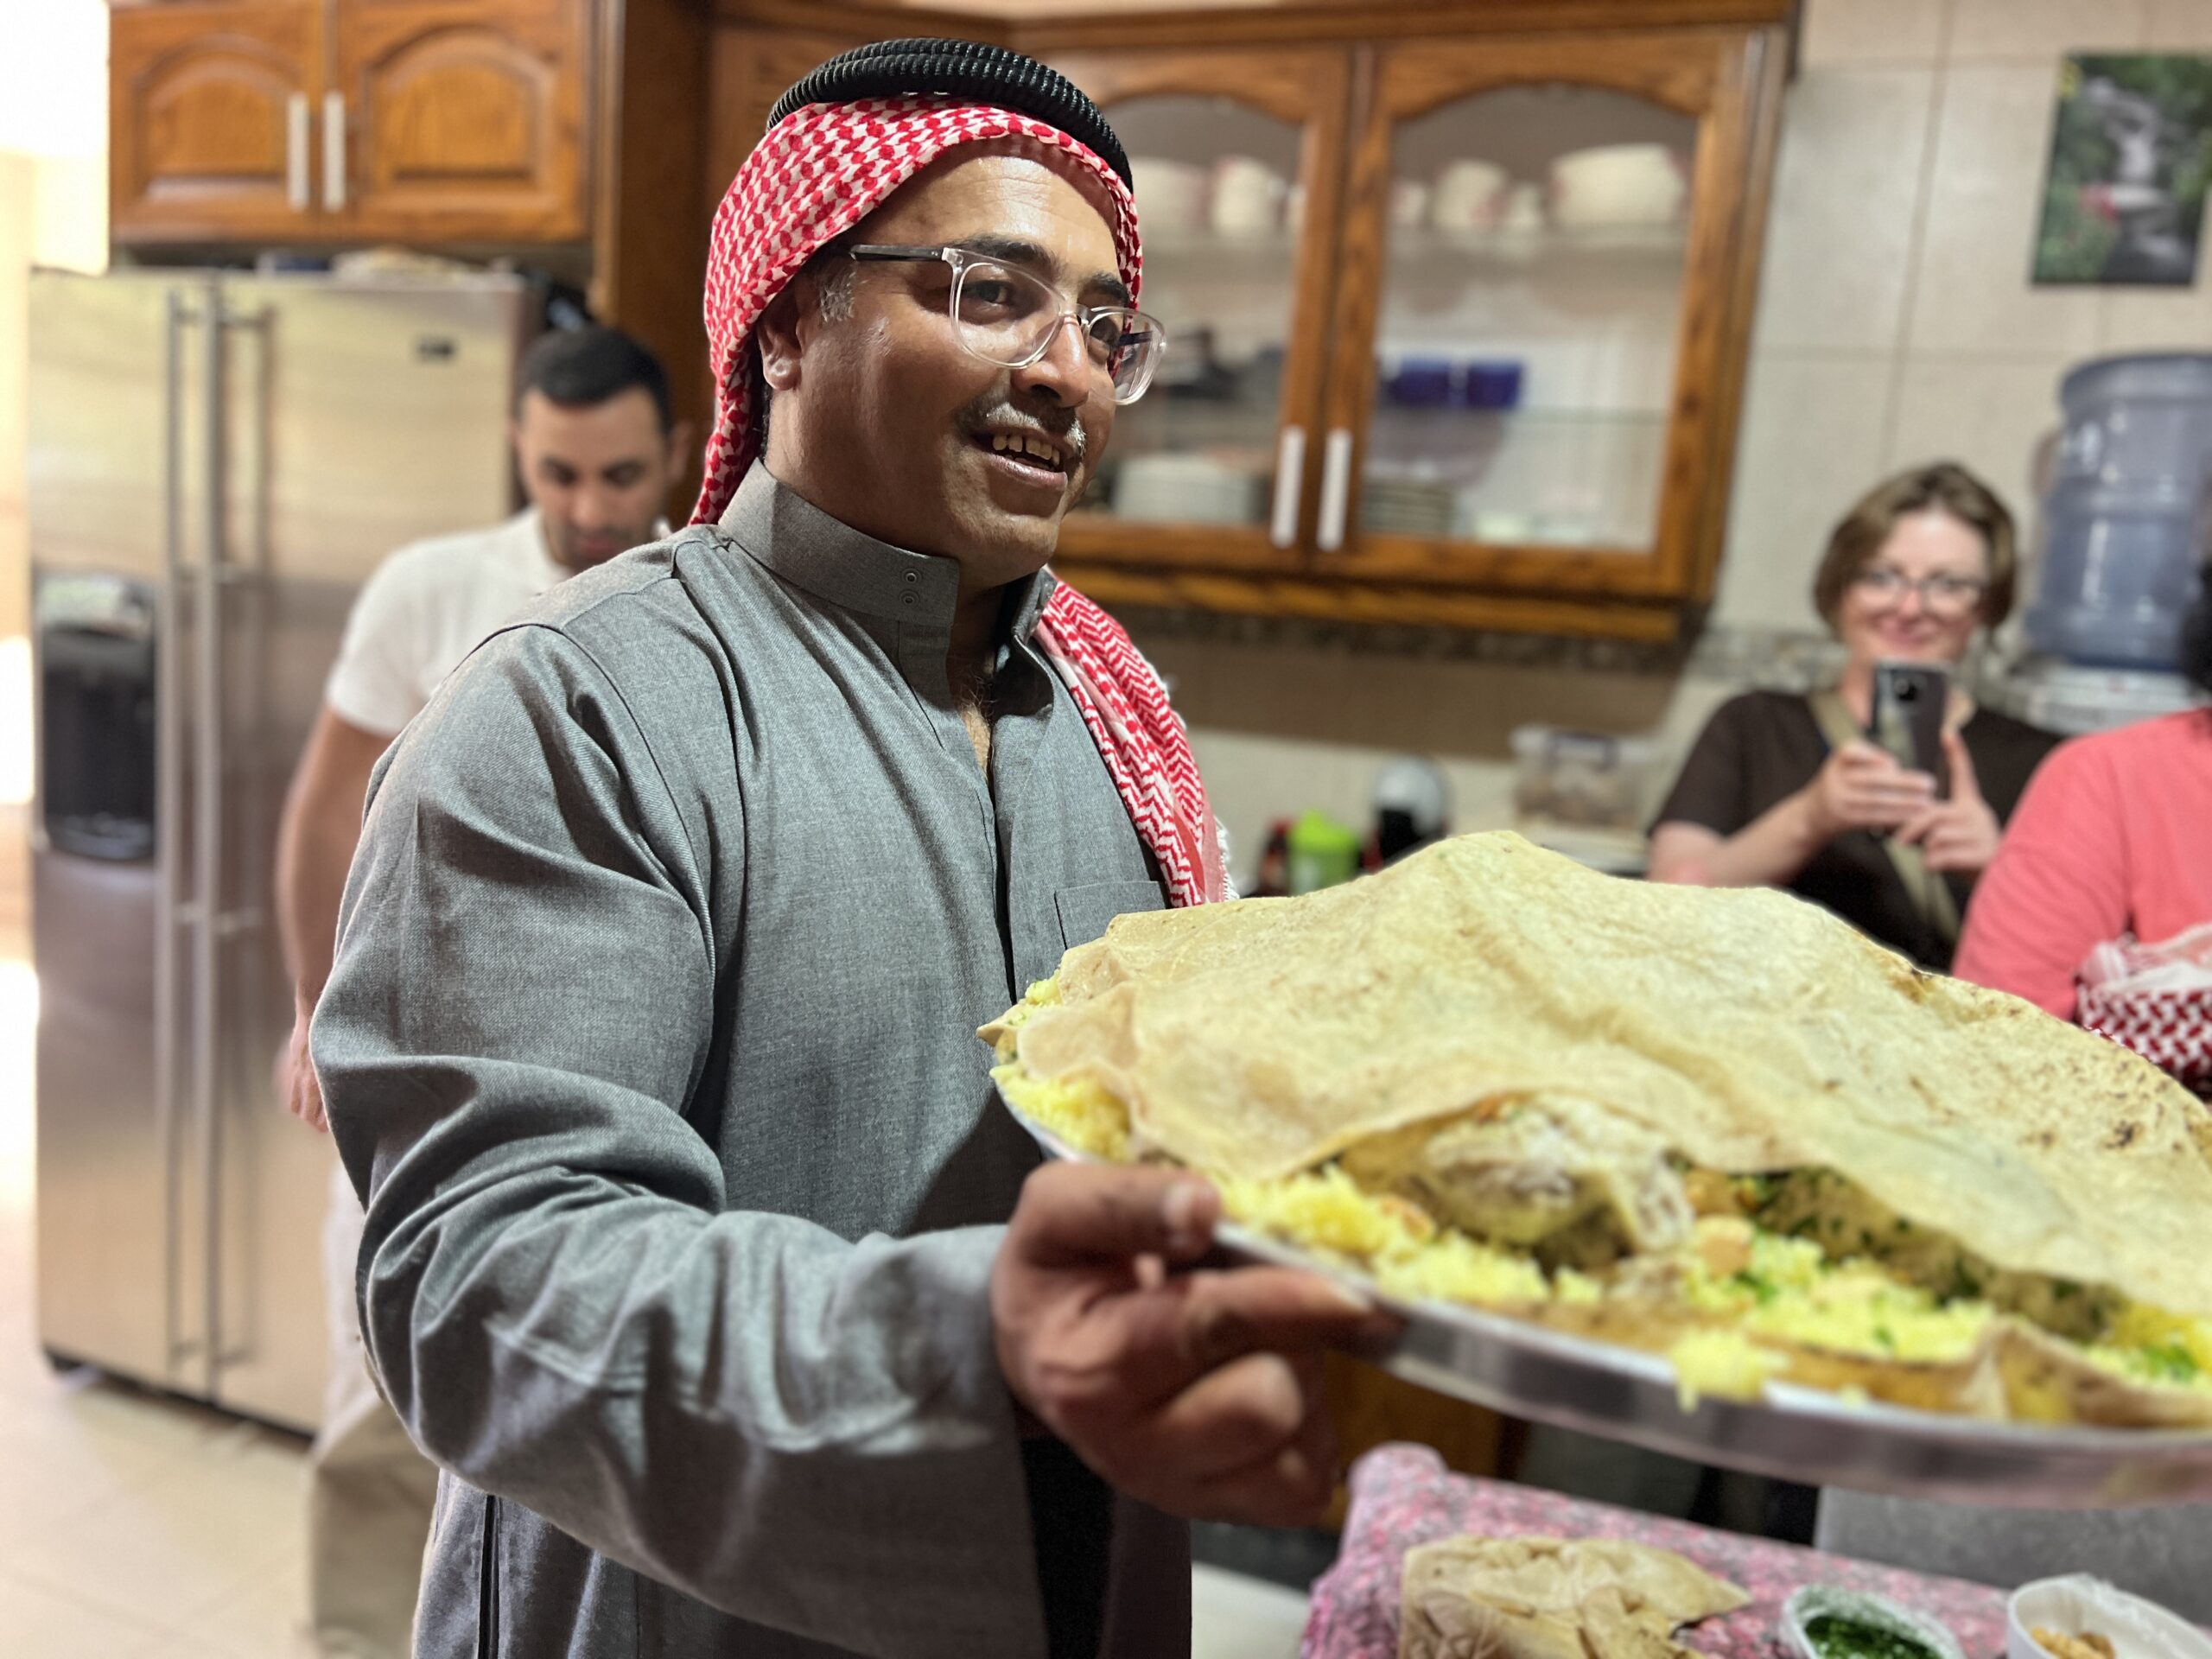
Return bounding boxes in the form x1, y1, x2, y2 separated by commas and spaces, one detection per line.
980, 834, 2212, 1427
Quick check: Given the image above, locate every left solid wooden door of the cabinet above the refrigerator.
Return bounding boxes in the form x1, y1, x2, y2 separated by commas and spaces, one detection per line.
108, 0, 319, 244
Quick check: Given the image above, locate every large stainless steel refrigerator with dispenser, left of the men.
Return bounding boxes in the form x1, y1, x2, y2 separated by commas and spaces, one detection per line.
29, 272, 537, 1429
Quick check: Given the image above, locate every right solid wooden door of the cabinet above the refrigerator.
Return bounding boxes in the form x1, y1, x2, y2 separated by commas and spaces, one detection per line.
321, 0, 588, 241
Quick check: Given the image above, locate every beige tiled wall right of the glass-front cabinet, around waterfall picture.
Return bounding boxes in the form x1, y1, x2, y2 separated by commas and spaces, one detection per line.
1719, 0, 2212, 626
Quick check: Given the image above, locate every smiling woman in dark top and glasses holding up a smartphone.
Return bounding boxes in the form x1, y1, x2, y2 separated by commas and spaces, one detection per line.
1650, 462, 2057, 969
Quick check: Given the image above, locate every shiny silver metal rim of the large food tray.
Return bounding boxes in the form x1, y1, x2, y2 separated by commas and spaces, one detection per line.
1007, 1106, 2212, 1509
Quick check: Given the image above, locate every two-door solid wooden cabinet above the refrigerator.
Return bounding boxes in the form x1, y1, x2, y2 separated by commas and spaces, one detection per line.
111, 0, 593, 245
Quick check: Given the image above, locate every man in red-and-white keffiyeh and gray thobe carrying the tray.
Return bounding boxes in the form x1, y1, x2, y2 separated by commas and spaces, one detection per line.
312, 42, 1376, 1659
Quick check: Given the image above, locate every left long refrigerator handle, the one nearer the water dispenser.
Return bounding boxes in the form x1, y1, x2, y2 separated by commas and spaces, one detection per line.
153, 288, 194, 1365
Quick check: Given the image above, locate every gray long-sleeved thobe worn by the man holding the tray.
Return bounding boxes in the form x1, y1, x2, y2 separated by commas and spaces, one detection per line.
315, 467, 1190, 1659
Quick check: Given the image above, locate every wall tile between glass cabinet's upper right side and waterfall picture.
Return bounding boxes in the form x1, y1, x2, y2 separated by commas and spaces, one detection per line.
1757, 68, 1936, 352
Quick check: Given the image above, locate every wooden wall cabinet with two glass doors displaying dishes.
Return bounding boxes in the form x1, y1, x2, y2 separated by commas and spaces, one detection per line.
708, 0, 1794, 641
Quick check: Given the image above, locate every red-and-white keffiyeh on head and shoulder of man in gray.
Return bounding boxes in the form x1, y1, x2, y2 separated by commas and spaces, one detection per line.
692, 95, 1228, 905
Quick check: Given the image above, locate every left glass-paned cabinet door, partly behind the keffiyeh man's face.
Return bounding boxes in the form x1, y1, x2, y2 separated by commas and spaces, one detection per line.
1055, 48, 1351, 586
